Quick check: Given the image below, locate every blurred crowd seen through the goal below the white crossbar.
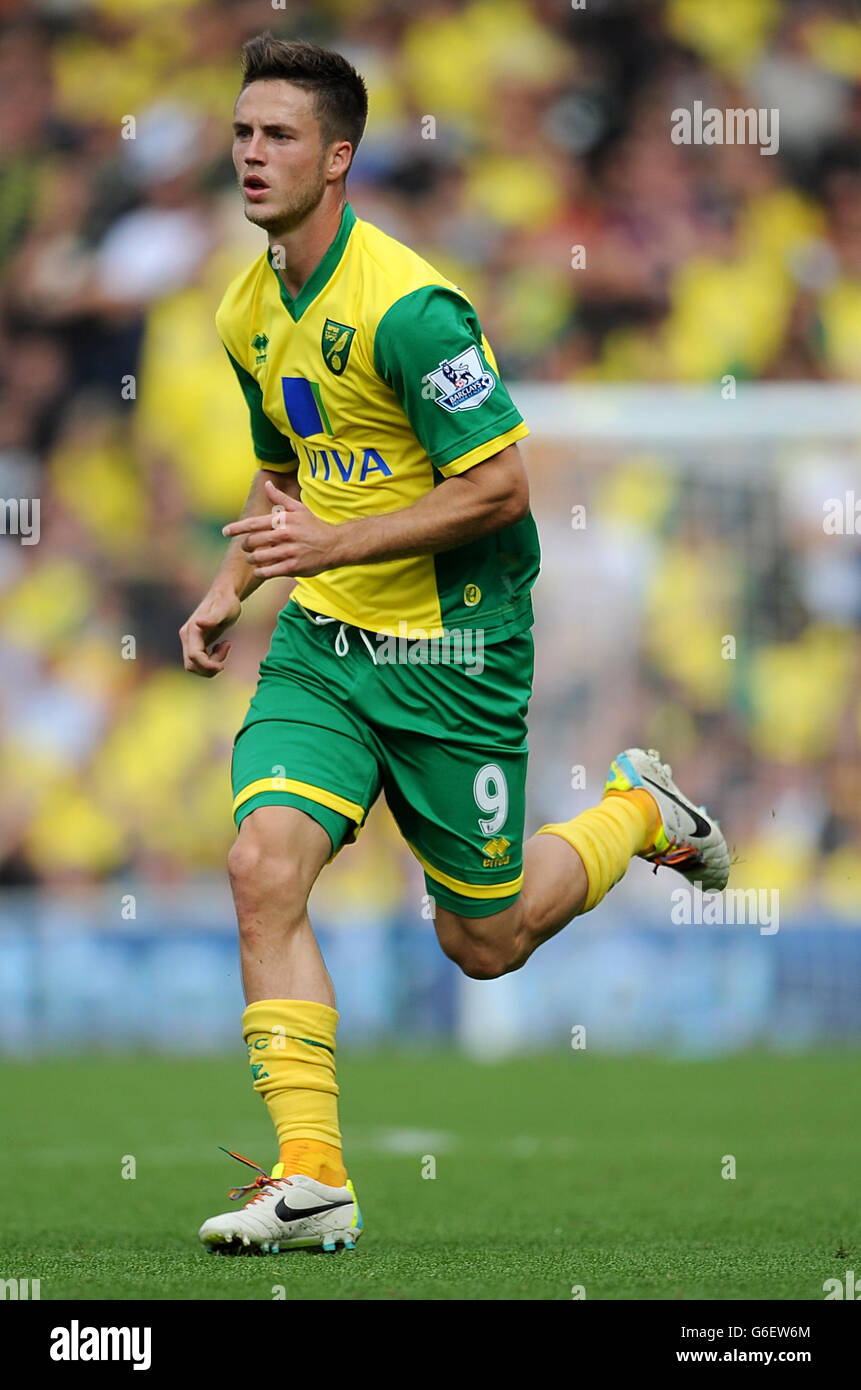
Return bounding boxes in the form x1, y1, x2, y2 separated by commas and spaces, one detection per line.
527, 427, 861, 922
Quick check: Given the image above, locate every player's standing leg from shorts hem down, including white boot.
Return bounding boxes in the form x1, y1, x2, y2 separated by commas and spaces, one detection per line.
200, 795, 362, 1254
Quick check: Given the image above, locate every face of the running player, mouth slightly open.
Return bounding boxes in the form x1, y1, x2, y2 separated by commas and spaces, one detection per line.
234, 79, 327, 235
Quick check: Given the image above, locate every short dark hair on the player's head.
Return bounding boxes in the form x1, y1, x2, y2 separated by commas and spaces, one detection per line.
241, 29, 367, 171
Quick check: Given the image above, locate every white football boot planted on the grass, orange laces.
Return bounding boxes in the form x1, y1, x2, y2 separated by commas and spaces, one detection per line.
200, 1150, 362, 1255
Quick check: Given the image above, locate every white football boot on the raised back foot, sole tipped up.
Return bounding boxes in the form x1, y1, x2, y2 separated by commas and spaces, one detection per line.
604, 748, 729, 892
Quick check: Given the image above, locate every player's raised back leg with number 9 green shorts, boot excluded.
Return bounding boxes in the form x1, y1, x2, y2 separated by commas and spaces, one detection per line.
377, 632, 645, 979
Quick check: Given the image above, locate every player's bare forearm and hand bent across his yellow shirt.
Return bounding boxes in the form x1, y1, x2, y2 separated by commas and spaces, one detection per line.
224, 445, 529, 581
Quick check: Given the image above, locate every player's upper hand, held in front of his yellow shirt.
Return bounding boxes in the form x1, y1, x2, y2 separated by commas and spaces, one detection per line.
221, 478, 344, 580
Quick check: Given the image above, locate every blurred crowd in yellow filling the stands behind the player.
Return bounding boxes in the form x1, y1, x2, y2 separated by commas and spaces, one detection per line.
0, 0, 861, 910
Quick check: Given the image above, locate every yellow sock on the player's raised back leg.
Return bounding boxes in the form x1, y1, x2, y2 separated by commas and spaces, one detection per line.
538, 787, 661, 912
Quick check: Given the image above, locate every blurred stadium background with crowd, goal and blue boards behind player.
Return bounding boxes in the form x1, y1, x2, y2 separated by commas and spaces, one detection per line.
0, 0, 861, 1056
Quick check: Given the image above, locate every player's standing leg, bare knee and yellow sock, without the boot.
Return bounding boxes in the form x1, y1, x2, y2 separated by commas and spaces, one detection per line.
228, 806, 346, 1187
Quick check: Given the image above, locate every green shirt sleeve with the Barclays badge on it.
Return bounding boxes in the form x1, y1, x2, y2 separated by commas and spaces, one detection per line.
374, 285, 523, 468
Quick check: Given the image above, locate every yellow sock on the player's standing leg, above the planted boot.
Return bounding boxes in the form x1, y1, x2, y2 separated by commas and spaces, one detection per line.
242, 999, 346, 1187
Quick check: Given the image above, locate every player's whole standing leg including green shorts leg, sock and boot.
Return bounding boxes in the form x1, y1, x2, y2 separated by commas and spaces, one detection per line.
200, 603, 380, 1252
